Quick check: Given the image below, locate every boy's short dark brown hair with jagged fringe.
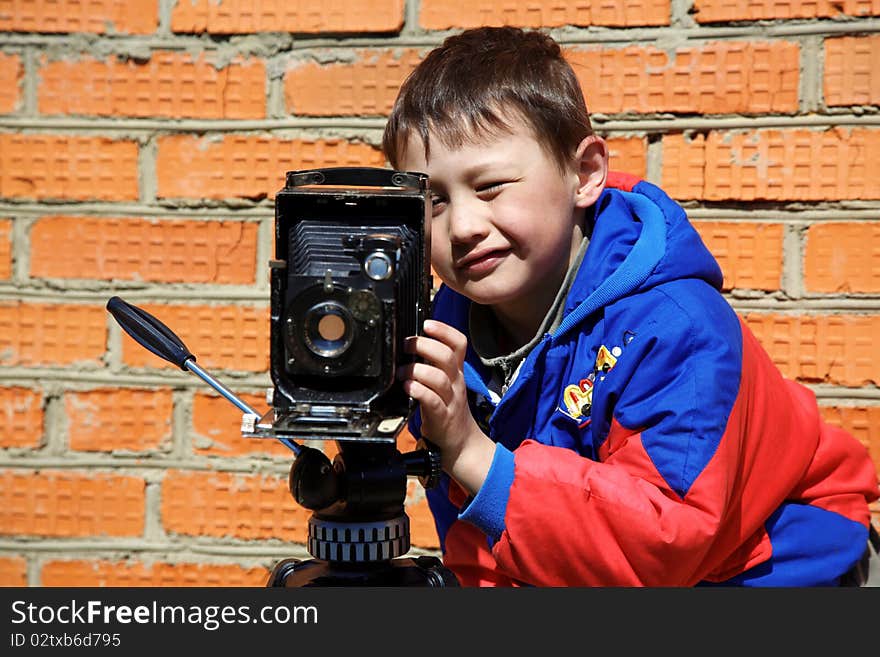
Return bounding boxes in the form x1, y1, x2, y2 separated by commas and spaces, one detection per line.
382, 27, 593, 169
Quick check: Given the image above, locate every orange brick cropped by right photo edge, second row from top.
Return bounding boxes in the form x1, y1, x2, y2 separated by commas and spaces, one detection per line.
823, 35, 880, 106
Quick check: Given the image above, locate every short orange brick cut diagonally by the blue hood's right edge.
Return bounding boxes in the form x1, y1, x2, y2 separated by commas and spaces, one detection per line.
694, 221, 783, 290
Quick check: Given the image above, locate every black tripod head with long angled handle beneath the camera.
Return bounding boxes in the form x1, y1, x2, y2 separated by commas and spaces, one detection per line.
107, 297, 459, 587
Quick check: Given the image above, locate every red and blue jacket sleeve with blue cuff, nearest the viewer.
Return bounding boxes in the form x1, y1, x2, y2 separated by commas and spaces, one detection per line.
462, 288, 876, 586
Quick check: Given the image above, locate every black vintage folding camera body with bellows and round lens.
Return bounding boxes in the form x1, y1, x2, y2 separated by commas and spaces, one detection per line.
254, 167, 432, 442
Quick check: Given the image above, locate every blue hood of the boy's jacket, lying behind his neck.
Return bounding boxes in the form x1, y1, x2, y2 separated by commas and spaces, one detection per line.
553, 181, 723, 338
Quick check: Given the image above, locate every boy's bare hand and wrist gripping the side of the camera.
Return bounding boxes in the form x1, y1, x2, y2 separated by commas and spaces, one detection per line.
397, 320, 495, 495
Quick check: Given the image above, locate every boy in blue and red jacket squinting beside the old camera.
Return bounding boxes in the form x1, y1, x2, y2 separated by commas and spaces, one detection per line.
383, 28, 878, 586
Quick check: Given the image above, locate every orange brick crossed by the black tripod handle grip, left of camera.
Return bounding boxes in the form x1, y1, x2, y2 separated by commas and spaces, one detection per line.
120, 304, 269, 372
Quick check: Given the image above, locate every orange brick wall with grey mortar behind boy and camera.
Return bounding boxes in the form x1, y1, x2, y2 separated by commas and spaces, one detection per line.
0, 0, 880, 586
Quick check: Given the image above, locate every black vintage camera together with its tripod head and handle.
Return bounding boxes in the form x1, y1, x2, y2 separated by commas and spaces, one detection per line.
107, 167, 458, 587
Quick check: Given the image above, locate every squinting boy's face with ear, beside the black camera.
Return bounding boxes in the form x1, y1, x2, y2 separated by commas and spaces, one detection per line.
400, 121, 604, 317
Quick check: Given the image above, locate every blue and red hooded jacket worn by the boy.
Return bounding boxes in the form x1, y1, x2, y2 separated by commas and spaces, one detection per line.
410, 176, 880, 586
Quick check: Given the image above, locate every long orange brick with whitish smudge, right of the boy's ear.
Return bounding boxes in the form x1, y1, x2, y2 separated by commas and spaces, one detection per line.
661, 128, 880, 201
